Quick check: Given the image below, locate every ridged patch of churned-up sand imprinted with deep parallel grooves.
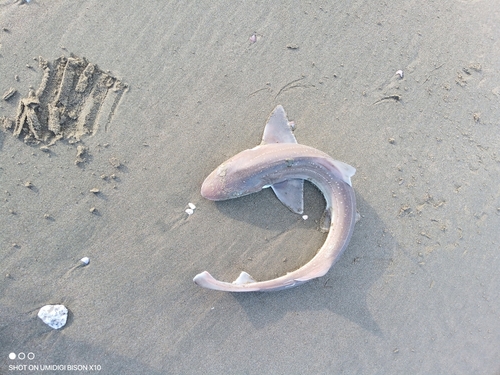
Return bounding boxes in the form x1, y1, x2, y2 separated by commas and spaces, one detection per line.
4, 55, 128, 144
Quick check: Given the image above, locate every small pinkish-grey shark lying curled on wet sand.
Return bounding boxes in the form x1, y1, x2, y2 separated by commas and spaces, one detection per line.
193, 106, 356, 292
